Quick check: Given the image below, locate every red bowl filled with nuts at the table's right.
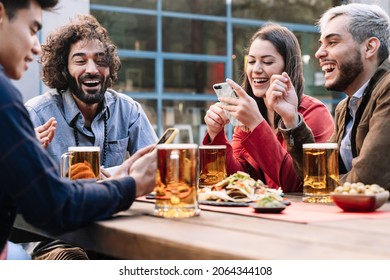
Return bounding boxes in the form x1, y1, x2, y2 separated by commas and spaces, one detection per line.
330, 182, 389, 212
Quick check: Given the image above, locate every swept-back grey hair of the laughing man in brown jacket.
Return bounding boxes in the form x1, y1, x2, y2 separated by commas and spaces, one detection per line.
317, 3, 390, 61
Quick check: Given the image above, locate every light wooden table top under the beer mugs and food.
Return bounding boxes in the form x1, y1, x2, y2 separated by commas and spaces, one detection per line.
14, 198, 390, 260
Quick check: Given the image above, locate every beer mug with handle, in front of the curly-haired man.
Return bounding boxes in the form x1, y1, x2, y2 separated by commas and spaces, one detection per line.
60, 146, 100, 180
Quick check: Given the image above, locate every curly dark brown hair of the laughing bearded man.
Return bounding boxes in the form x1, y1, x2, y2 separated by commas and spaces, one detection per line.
40, 15, 121, 92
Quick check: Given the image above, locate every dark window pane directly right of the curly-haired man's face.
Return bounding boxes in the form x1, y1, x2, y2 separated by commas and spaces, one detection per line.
114, 57, 155, 92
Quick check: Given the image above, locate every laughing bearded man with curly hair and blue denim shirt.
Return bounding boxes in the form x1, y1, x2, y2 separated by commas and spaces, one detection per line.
25, 15, 157, 167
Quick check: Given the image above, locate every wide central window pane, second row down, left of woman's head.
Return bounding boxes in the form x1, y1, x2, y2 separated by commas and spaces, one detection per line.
163, 18, 226, 55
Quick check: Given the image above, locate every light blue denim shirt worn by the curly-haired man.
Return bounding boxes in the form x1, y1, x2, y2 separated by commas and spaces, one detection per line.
25, 89, 157, 168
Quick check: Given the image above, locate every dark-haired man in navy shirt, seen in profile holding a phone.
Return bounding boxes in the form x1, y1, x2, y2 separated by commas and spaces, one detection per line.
0, 0, 157, 259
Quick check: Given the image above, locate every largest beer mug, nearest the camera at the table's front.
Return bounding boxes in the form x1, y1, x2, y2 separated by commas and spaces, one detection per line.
154, 144, 200, 218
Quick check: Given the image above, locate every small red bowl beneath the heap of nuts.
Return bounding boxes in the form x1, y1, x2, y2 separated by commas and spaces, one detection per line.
330, 191, 389, 212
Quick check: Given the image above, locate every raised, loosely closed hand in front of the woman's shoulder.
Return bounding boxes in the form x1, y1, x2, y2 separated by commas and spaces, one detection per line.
266, 72, 299, 128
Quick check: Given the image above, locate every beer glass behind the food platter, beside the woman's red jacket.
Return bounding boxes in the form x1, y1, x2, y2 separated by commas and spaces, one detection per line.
199, 145, 226, 187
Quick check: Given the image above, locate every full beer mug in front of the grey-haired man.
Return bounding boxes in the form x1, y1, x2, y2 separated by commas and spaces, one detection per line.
303, 143, 339, 203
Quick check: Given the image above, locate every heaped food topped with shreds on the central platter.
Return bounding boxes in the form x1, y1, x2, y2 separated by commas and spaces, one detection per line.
198, 171, 283, 202
